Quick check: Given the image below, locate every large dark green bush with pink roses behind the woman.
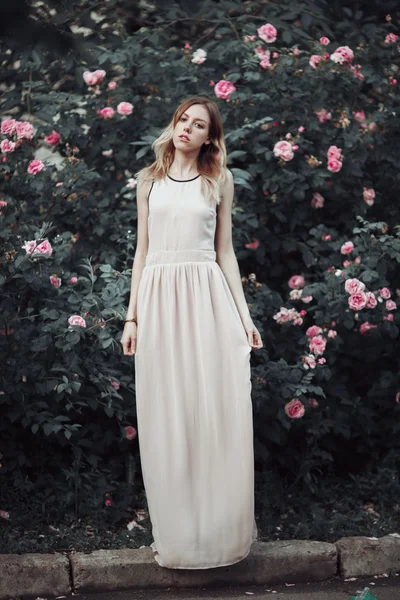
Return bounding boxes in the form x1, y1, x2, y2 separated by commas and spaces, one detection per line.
0, 0, 400, 510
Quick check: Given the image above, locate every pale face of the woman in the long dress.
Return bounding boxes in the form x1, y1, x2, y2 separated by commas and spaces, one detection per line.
172, 104, 210, 152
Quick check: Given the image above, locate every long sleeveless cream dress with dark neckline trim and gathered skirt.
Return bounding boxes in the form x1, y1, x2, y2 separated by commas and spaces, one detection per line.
135, 176, 257, 569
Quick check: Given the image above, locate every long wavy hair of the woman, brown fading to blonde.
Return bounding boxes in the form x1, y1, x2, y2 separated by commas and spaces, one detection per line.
135, 96, 226, 204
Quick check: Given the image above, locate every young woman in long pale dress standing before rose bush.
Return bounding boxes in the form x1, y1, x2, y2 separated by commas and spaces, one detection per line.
121, 97, 263, 569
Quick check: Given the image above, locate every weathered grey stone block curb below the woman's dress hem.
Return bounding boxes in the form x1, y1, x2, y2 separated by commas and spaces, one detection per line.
0, 533, 400, 600
